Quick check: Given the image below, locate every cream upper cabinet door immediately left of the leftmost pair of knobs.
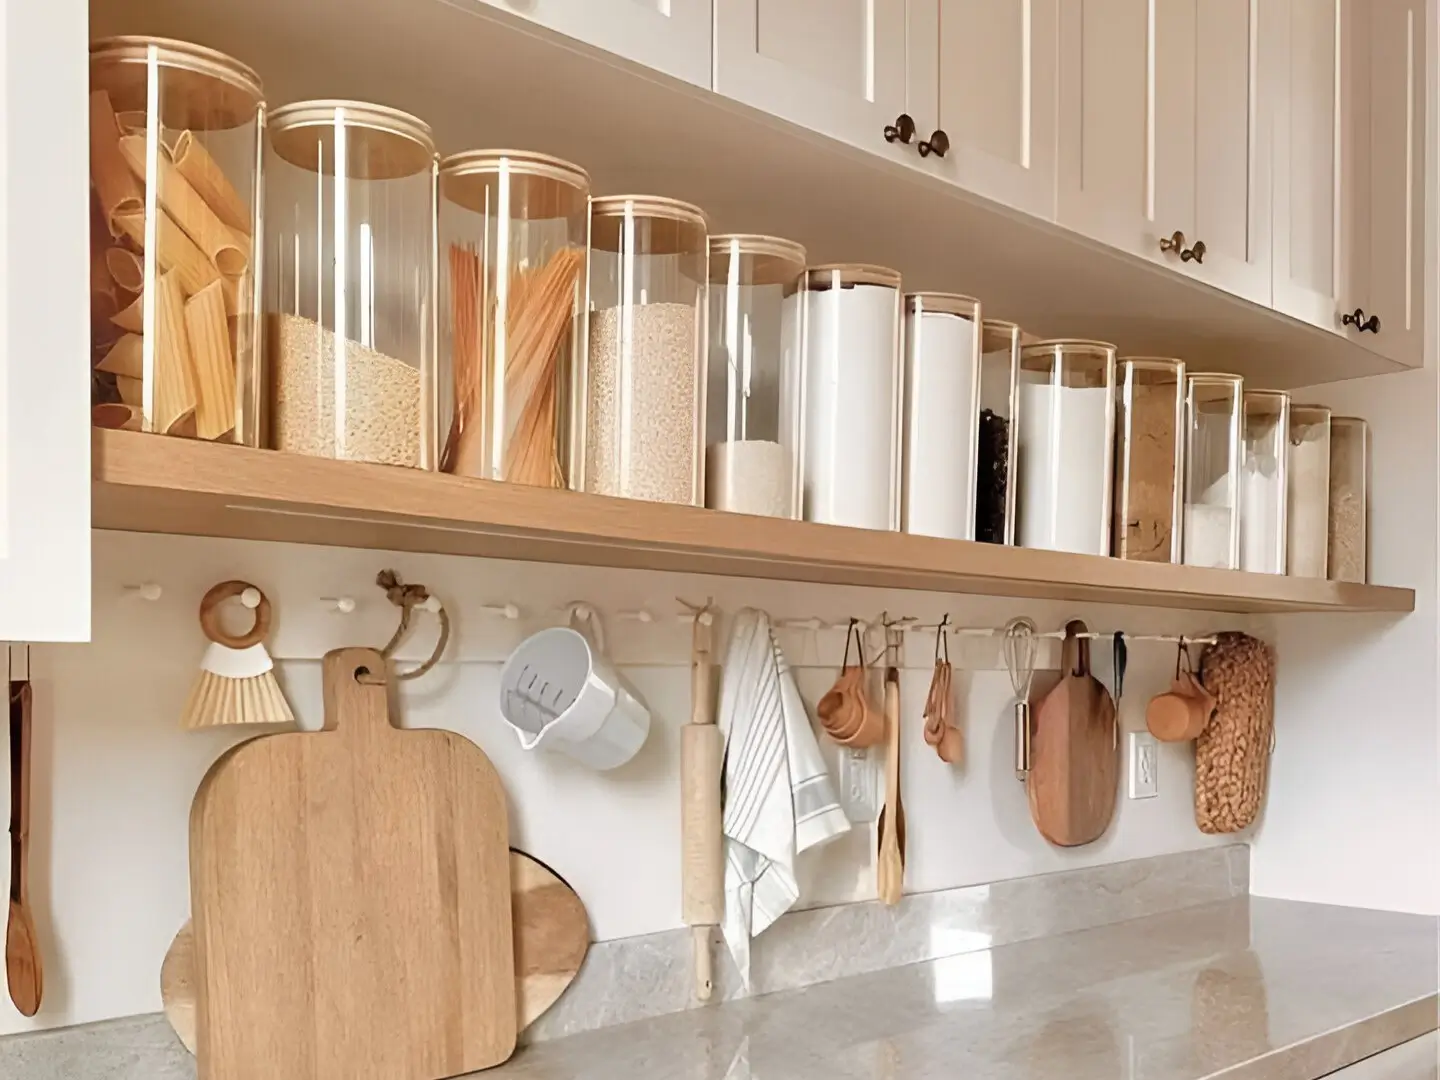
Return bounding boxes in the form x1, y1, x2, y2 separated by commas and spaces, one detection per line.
716, 0, 916, 158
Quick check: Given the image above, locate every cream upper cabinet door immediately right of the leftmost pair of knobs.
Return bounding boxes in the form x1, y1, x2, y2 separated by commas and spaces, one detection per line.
910, 0, 1060, 222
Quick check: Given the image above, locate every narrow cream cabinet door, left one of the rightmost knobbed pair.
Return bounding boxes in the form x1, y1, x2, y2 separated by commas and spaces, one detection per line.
1266, 0, 1365, 331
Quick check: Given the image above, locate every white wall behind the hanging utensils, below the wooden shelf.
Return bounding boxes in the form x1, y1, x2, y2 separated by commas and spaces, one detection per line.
0, 533, 1246, 1034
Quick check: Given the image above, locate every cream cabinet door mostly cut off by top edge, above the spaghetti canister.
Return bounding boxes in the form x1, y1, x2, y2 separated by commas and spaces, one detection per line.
481, 0, 711, 89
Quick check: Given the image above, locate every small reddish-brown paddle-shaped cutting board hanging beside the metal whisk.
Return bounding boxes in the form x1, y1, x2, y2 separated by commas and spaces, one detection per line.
1025, 621, 1120, 848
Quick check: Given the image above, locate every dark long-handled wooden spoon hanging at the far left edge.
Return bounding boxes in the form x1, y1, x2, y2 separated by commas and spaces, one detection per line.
4, 659, 45, 1017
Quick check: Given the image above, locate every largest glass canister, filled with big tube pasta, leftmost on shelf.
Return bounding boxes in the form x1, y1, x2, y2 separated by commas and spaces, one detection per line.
89, 37, 265, 446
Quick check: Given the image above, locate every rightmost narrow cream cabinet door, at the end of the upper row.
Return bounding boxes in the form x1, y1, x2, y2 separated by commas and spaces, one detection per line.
1346, 0, 1426, 366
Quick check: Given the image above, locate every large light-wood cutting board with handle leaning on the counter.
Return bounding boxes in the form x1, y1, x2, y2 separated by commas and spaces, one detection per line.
190, 648, 516, 1080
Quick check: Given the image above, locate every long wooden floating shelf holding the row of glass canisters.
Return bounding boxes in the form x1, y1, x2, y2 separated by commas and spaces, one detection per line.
92, 431, 1416, 613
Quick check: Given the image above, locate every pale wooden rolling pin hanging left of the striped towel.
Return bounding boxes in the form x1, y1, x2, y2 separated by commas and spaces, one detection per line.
680, 608, 724, 1001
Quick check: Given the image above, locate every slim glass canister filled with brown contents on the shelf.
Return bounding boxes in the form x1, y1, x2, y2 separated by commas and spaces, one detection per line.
1110, 356, 1185, 563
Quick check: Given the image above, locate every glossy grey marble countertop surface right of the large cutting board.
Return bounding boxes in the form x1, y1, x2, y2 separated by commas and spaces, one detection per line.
484, 897, 1437, 1080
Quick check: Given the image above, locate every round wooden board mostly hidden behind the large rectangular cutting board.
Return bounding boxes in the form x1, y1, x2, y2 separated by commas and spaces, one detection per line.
160, 848, 590, 1054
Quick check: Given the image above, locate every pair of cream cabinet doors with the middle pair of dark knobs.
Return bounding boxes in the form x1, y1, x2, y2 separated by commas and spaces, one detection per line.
1058, 0, 1272, 304
